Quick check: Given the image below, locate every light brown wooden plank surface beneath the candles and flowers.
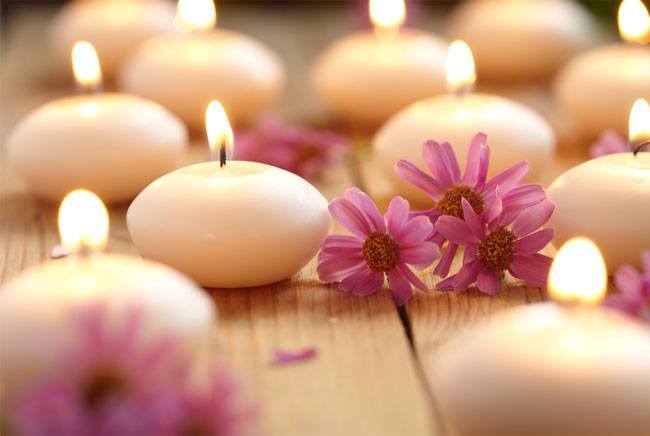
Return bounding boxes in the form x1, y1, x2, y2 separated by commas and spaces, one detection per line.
0, 7, 580, 435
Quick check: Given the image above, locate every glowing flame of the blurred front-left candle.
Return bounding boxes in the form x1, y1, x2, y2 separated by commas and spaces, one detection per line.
59, 189, 108, 252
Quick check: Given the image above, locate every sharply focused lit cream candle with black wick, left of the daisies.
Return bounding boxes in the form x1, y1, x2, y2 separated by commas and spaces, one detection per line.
127, 101, 329, 288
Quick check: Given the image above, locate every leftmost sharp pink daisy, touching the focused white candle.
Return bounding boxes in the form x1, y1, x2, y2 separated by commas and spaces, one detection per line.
318, 188, 439, 305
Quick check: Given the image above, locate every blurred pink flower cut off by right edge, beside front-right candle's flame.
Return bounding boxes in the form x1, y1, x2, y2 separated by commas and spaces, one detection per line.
605, 250, 650, 321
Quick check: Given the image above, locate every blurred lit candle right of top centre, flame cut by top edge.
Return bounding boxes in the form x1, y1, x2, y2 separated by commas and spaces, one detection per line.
312, 0, 446, 125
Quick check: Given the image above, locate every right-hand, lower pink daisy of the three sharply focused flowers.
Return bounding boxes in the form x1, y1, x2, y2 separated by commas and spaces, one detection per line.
436, 198, 554, 295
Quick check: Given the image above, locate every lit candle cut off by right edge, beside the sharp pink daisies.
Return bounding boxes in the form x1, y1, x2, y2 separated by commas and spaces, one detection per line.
548, 99, 650, 271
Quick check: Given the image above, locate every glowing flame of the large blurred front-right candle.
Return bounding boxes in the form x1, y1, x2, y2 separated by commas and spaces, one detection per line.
548, 237, 607, 304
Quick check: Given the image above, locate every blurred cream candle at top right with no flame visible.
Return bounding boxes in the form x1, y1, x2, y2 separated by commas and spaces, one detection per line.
450, 0, 596, 81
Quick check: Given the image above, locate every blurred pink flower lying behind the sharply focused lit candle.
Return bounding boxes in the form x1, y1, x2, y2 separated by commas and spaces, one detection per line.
235, 117, 350, 178
